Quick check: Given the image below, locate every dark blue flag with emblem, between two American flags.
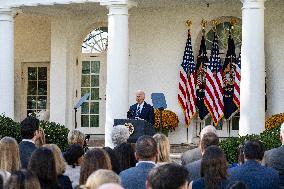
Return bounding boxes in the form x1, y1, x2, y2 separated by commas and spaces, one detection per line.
196, 35, 209, 120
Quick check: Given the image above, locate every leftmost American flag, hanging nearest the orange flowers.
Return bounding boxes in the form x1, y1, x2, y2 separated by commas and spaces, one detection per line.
178, 31, 196, 127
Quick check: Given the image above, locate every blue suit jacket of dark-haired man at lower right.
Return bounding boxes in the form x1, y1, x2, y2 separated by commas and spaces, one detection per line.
229, 160, 280, 189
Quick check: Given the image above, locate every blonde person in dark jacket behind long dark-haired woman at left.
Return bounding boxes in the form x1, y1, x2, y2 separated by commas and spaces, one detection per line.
43, 144, 72, 189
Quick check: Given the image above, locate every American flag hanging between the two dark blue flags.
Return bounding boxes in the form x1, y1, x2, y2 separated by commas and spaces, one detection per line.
204, 33, 224, 126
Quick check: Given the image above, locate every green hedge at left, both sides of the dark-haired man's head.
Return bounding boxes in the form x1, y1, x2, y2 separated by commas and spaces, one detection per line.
0, 115, 69, 151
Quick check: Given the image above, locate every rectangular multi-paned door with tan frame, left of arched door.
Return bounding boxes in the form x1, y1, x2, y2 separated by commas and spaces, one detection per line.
21, 62, 50, 119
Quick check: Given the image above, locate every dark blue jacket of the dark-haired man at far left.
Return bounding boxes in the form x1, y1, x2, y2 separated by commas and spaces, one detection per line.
19, 141, 37, 169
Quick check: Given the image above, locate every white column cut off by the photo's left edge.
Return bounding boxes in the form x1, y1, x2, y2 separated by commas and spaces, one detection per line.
0, 8, 14, 119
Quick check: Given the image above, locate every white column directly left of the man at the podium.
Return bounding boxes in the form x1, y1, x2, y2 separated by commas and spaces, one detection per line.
101, 1, 137, 147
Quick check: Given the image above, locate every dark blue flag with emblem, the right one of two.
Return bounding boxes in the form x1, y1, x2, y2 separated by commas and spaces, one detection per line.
223, 34, 238, 119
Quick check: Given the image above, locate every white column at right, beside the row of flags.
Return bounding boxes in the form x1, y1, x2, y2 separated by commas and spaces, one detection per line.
239, 0, 265, 136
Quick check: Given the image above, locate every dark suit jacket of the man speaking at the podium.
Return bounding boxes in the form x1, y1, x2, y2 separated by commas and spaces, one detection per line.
127, 102, 155, 125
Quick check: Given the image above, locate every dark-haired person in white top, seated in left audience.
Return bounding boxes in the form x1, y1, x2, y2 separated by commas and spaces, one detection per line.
64, 144, 84, 188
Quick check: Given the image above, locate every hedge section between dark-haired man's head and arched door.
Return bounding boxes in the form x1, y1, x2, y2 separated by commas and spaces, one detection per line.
40, 121, 69, 151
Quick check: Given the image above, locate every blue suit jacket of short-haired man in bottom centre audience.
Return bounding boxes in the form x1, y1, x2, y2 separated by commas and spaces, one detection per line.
119, 162, 155, 189
